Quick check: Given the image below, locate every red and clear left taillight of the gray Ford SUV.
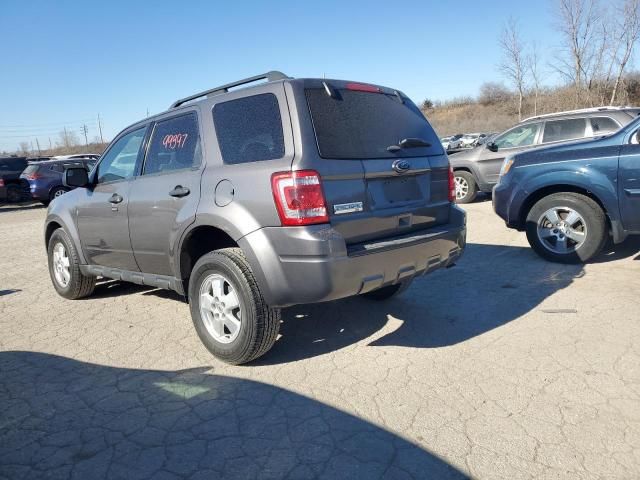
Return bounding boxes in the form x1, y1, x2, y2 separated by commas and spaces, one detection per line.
271, 170, 329, 226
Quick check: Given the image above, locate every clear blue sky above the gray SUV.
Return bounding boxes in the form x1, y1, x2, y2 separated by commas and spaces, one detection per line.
0, 0, 557, 150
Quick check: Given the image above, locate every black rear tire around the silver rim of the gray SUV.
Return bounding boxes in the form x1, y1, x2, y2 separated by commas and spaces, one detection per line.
189, 248, 280, 365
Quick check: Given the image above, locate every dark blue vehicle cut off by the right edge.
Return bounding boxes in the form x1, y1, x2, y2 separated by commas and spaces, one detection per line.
493, 119, 640, 263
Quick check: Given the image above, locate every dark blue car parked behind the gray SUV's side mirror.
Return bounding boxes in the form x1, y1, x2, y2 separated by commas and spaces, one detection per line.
20, 158, 96, 205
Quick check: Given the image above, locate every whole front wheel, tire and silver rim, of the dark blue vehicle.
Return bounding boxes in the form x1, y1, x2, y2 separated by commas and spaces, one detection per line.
526, 193, 607, 263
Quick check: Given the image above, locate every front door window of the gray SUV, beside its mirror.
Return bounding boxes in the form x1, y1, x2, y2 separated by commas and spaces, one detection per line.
95, 127, 147, 183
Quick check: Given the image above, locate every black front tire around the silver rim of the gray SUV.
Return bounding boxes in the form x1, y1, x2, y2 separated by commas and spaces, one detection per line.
47, 228, 96, 300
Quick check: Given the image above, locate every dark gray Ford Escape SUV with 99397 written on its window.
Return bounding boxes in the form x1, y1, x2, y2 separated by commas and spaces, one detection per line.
45, 72, 466, 364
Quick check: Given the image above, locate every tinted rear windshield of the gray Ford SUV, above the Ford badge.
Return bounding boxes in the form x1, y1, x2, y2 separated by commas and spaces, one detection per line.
305, 88, 444, 159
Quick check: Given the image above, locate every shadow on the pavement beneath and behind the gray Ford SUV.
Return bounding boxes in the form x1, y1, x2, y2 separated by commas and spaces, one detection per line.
255, 244, 584, 364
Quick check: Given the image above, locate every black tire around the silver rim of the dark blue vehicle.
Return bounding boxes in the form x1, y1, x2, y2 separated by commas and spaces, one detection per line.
526, 193, 608, 263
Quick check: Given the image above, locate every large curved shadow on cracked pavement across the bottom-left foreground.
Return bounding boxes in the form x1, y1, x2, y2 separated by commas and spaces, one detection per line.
0, 351, 467, 479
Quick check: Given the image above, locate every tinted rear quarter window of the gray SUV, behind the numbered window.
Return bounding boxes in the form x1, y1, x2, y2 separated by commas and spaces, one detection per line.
213, 93, 284, 164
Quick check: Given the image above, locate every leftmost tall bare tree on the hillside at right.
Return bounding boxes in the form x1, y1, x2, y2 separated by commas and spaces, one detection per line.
499, 18, 528, 120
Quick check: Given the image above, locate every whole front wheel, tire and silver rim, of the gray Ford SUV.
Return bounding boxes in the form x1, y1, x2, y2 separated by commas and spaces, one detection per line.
47, 228, 96, 300
